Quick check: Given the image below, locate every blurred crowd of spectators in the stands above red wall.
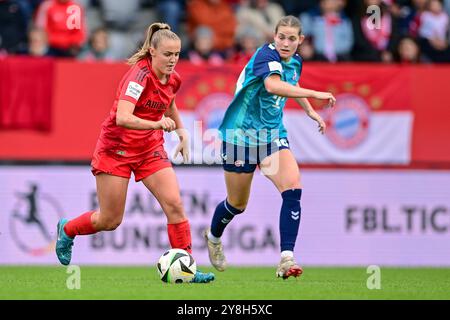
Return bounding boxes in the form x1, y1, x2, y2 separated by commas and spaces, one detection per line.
0, 0, 450, 65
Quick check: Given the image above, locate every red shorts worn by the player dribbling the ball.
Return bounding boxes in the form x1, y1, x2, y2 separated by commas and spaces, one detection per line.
91, 146, 172, 182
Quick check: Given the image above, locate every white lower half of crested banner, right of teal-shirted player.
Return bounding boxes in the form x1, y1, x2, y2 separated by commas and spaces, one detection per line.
285, 111, 413, 164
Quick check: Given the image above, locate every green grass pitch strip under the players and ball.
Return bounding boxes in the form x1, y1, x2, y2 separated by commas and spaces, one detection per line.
0, 266, 450, 300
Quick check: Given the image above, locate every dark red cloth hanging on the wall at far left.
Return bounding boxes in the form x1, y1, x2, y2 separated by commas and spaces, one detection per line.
0, 57, 54, 131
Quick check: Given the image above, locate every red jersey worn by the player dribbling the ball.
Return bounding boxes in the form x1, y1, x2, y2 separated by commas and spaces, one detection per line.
96, 58, 181, 158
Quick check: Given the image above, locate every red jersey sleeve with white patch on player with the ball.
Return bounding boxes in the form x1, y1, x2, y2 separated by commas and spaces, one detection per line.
119, 65, 150, 104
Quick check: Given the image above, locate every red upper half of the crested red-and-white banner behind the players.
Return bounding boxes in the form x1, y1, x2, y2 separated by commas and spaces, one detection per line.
177, 63, 413, 110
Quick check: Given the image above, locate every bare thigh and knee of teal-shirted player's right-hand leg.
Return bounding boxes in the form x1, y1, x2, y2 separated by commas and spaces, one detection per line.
260, 149, 301, 192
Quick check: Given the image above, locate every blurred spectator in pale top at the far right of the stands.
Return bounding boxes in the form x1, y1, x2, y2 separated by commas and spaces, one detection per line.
419, 0, 450, 62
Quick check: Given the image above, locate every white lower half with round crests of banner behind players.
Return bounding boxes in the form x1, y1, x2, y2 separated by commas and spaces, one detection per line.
166, 93, 414, 164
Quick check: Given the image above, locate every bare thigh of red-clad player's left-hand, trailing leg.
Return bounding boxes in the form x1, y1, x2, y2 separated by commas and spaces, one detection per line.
95, 173, 129, 224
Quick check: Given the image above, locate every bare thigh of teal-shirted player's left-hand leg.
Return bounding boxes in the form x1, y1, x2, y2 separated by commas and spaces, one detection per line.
225, 171, 253, 210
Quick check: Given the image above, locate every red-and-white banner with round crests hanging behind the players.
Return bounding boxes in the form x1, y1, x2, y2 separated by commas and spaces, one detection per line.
172, 65, 414, 165
